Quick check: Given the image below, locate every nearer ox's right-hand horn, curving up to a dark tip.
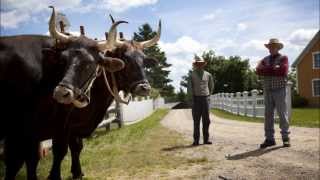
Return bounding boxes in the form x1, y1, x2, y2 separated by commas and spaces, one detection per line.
98, 21, 128, 51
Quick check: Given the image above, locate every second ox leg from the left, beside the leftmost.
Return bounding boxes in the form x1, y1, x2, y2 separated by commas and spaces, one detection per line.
26, 141, 40, 180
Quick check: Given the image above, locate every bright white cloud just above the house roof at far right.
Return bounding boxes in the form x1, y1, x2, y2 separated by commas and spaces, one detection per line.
289, 29, 317, 46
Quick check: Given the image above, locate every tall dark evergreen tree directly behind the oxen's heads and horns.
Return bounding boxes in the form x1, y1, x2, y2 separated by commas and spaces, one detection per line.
133, 24, 175, 97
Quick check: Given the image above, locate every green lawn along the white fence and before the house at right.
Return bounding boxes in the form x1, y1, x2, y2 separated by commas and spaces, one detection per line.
211, 108, 320, 128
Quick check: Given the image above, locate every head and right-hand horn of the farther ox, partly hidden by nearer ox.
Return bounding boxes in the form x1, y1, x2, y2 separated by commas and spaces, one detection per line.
102, 18, 161, 100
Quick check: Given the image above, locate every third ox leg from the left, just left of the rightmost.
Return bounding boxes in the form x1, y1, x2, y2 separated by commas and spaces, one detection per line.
48, 139, 68, 180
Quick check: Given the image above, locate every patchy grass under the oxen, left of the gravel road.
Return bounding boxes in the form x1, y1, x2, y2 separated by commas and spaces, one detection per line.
0, 109, 205, 180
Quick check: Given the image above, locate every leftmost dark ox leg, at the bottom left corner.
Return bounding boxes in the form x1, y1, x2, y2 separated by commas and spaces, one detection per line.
4, 137, 24, 180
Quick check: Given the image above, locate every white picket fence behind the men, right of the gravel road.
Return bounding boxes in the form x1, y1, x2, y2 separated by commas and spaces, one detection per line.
210, 82, 292, 120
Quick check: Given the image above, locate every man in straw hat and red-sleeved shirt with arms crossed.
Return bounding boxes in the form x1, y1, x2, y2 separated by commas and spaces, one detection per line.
256, 39, 290, 148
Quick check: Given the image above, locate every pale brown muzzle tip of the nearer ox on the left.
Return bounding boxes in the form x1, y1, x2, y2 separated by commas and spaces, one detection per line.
53, 86, 74, 104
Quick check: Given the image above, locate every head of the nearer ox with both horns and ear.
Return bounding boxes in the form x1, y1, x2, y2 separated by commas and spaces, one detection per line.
49, 6, 126, 108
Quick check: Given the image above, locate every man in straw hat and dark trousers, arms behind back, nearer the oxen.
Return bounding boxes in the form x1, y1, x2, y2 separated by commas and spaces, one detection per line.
188, 56, 213, 146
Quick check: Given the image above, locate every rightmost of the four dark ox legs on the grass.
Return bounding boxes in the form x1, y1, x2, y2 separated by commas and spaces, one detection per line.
69, 137, 84, 179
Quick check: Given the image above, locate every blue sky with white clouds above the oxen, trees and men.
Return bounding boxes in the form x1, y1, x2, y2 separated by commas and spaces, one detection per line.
0, 0, 319, 89
